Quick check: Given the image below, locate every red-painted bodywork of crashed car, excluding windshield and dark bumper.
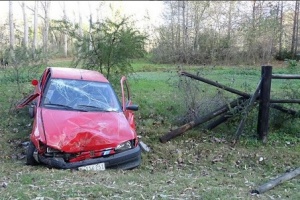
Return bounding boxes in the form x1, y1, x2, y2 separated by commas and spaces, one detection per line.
17, 68, 138, 166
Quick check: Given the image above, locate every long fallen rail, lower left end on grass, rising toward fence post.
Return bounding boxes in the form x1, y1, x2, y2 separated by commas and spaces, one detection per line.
159, 98, 245, 143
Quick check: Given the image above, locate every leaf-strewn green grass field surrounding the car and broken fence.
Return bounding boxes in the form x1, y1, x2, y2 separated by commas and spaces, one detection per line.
0, 59, 300, 200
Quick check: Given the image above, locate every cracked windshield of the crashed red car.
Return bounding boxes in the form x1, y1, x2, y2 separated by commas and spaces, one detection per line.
42, 79, 121, 112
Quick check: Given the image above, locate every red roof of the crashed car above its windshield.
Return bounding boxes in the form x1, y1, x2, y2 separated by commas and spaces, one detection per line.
49, 67, 109, 83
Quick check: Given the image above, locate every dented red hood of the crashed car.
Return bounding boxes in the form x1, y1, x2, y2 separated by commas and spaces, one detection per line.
42, 108, 135, 153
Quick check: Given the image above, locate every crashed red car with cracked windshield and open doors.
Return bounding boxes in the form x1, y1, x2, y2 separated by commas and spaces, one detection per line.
17, 67, 141, 170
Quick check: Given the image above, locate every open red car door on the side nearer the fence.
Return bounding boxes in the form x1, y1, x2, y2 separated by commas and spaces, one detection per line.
121, 76, 138, 130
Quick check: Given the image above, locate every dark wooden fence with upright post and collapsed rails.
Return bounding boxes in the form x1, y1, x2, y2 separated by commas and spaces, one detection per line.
160, 66, 300, 143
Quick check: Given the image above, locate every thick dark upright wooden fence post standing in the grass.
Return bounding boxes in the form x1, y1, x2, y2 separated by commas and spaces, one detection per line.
257, 66, 272, 143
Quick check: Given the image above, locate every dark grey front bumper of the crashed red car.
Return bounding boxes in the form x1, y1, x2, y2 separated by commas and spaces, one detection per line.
38, 145, 141, 169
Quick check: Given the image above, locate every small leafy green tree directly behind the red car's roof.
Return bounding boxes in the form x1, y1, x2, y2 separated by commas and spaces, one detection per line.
56, 14, 147, 81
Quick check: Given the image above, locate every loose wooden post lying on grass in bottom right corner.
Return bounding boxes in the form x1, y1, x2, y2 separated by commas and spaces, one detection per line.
251, 167, 300, 194
